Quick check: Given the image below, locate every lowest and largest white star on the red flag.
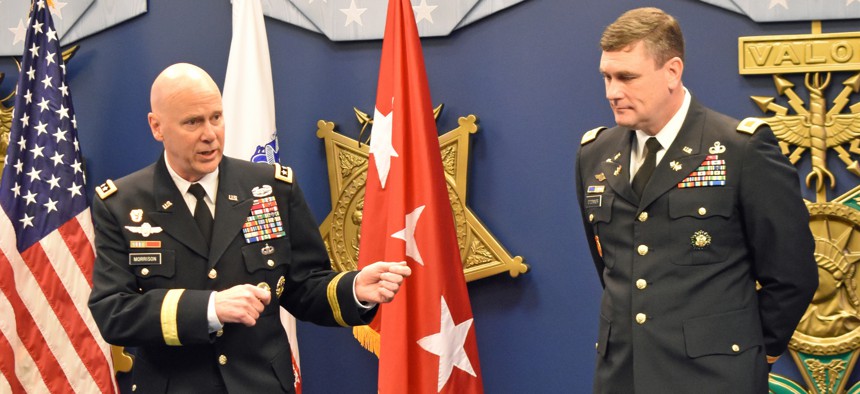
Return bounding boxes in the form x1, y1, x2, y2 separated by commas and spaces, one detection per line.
418, 296, 477, 391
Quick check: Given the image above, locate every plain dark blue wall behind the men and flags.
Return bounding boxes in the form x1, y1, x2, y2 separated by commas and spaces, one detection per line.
0, 0, 860, 393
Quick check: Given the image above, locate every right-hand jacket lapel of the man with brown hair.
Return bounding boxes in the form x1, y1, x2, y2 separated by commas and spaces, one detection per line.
639, 98, 707, 209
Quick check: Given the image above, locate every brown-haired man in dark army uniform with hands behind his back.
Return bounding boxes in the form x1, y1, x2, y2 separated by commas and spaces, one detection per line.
576, 8, 818, 393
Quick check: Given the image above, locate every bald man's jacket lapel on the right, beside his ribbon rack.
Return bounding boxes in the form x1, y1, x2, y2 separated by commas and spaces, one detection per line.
209, 156, 254, 268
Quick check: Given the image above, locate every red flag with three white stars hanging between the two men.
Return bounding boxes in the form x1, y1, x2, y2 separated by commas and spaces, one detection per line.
352, 0, 483, 394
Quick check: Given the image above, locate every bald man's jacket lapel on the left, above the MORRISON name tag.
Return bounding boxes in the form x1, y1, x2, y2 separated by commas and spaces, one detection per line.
149, 154, 209, 257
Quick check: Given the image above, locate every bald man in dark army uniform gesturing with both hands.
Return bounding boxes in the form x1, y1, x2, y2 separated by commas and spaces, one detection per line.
89, 63, 411, 393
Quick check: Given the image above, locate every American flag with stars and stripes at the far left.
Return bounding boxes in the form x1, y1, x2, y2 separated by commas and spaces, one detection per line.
0, 1, 116, 393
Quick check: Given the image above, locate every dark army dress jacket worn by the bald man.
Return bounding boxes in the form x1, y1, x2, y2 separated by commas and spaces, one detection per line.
89, 156, 376, 393
